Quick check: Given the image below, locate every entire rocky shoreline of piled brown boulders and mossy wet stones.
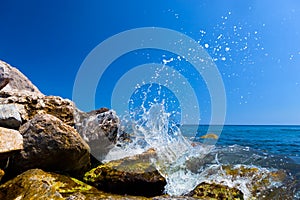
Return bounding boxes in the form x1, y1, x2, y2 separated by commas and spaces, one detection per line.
0, 61, 296, 200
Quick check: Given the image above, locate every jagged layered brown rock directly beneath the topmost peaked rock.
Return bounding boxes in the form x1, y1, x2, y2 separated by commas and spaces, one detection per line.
0, 91, 77, 126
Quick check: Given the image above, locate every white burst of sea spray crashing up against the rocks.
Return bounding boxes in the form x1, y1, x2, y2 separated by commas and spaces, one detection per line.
103, 104, 213, 196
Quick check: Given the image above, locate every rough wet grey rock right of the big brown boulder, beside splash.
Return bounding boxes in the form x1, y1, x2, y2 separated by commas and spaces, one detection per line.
75, 108, 120, 161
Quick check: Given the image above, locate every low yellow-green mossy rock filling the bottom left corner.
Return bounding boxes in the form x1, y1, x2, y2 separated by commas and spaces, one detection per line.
0, 169, 155, 200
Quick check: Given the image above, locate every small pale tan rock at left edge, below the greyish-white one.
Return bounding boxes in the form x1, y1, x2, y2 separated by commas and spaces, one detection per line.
0, 127, 23, 162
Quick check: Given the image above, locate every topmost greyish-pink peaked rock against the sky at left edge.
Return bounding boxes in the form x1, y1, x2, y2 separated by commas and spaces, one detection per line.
0, 60, 42, 95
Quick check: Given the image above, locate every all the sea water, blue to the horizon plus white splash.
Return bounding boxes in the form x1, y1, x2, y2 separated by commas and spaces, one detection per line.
103, 104, 300, 199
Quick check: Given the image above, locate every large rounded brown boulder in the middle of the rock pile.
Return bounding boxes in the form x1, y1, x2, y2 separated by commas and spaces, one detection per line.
9, 114, 90, 175
